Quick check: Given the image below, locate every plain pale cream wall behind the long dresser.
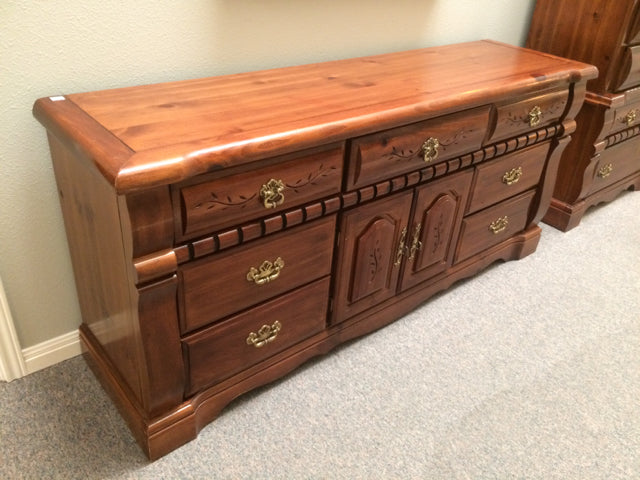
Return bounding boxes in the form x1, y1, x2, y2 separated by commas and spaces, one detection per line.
0, 0, 534, 347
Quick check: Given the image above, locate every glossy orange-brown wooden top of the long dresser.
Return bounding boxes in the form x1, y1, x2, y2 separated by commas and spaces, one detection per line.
34, 40, 597, 191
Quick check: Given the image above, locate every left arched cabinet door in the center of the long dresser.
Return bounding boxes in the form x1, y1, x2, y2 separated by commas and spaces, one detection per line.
332, 191, 413, 324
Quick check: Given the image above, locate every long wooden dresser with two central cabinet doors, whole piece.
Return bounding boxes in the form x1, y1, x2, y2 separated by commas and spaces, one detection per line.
34, 41, 597, 459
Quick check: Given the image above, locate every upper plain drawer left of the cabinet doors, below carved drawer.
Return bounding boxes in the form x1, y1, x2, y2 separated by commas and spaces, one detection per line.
179, 215, 335, 332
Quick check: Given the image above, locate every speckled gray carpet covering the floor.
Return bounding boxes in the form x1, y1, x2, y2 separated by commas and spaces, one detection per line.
0, 193, 640, 480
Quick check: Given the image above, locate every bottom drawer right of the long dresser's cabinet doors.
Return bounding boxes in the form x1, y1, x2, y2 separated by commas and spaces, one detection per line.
456, 190, 535, 262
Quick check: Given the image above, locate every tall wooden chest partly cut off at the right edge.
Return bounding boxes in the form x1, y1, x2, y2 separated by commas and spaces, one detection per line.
527, 0, 640, 231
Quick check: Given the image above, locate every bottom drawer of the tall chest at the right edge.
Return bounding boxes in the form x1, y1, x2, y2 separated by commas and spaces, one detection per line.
589, 137, 640, 193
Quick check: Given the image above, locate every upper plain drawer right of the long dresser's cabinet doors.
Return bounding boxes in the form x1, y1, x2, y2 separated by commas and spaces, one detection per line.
467, 143, 549, 213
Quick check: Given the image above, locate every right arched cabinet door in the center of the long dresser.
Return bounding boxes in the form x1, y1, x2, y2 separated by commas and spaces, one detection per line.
402, 170, 473, 289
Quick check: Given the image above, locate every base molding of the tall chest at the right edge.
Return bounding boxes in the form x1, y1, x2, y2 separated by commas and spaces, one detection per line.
542, 172, 640, 232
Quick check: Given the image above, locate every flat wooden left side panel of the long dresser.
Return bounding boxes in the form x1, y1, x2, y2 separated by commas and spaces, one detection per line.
48, 135, 142, 401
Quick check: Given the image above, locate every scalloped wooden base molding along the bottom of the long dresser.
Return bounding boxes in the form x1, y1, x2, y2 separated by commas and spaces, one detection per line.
79, 225, 541, 460
